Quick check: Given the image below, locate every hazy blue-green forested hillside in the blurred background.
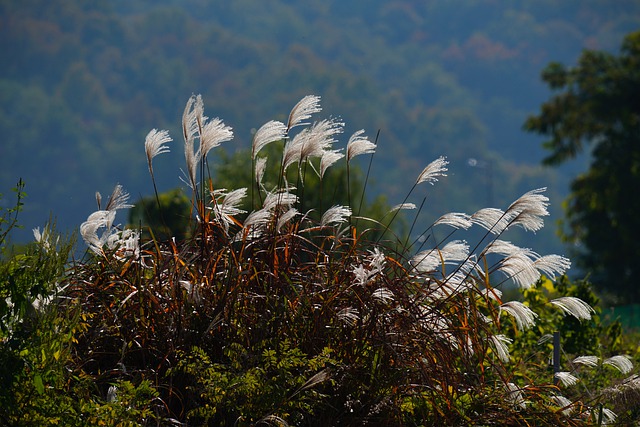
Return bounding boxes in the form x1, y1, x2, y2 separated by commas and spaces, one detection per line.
0, 0, 640, 262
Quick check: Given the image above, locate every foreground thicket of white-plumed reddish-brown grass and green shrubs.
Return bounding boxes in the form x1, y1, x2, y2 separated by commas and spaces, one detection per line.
0, 96, 640, 426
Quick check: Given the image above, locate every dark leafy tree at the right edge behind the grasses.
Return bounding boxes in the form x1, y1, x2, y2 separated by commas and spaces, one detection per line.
525, 32, 640, 302
